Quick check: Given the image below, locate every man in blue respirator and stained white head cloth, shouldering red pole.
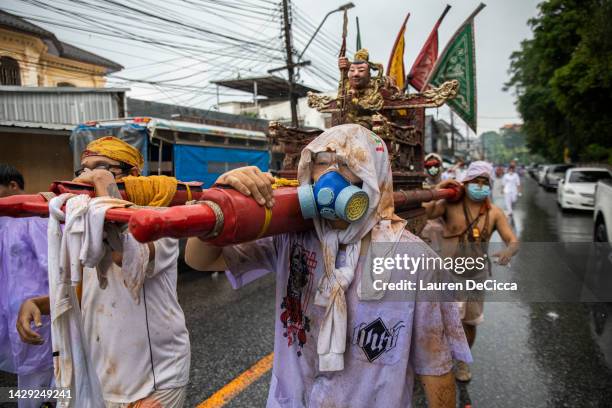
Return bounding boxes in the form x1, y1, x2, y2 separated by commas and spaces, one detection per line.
186, 124, 471, 408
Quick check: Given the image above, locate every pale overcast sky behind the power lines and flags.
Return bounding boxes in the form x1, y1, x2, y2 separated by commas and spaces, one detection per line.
2, 0, 538, 134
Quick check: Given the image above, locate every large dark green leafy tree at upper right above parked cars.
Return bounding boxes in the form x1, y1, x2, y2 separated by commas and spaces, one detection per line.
505, 0, 612, 161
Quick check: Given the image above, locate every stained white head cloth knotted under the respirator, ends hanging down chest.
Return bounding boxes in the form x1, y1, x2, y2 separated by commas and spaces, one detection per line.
298, 124, 406, 371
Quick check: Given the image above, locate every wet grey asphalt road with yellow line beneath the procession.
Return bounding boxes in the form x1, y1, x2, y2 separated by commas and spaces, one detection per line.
0, 176, 612, 408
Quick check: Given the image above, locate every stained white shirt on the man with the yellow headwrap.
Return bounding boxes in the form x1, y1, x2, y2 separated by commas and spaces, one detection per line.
82, 238, 191, 403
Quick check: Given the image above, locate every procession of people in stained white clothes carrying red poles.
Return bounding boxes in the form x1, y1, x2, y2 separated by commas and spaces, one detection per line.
0, 124, 520, 408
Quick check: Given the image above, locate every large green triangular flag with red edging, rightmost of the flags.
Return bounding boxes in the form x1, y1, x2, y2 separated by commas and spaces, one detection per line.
427, 3, 485, 132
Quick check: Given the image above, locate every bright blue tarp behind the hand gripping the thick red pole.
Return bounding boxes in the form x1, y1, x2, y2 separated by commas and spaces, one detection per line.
174, 145, 270, 188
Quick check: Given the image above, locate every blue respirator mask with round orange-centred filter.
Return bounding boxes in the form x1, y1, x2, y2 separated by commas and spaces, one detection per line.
297, 171, 370, 222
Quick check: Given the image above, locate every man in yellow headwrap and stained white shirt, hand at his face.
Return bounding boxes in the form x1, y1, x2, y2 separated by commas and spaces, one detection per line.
17, 136, 190, 407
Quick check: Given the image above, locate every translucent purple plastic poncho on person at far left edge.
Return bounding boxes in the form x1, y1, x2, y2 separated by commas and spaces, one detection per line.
0, 217, 53, 375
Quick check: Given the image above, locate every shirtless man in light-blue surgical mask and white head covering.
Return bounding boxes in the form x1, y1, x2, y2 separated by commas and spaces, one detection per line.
424, 161, 518, 381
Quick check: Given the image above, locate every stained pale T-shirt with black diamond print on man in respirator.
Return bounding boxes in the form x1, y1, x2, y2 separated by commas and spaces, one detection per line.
223, 231, 471, 408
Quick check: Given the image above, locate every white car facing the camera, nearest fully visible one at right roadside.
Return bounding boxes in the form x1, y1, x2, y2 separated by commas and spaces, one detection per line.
557, 167, 612, 210
